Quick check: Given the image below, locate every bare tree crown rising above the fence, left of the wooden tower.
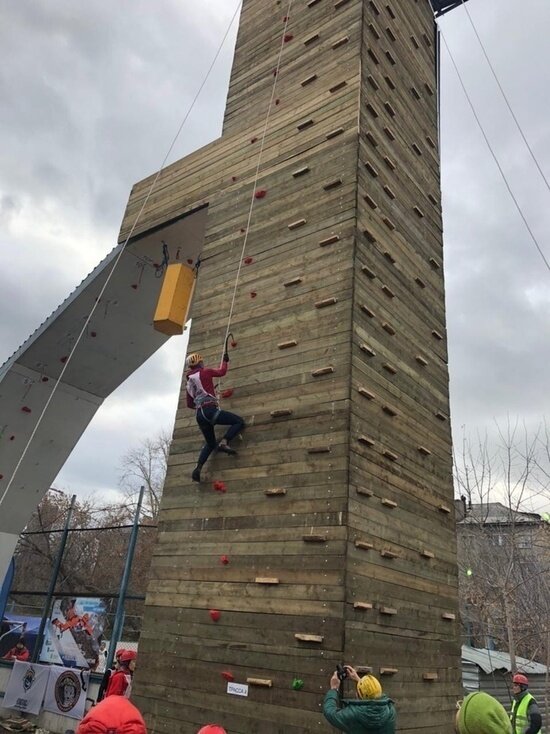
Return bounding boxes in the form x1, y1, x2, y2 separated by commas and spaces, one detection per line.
120, 431, 172, 519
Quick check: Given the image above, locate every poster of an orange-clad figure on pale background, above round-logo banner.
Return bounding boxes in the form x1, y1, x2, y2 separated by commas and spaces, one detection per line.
40, 597, 106, 670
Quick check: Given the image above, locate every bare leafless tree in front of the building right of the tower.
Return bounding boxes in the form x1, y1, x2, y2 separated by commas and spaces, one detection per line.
454, 422, 550, 668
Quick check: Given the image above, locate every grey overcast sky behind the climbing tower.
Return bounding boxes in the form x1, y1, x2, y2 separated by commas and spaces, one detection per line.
0, 0, 550, 516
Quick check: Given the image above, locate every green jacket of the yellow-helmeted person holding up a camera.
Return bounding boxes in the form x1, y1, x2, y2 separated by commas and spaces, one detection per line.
323, 690, 396, 734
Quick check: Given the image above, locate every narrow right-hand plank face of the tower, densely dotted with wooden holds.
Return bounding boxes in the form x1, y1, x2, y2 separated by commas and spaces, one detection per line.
345, 0, 460, 732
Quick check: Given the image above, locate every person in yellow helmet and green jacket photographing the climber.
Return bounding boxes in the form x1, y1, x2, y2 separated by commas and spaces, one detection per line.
323, 665, 396, 734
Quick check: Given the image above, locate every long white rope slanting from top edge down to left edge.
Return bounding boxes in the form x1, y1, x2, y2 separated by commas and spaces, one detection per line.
0, 0, 242, 506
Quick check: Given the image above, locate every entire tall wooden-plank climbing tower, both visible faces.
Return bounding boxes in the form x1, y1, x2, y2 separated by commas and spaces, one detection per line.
121, 0, 460, 734
